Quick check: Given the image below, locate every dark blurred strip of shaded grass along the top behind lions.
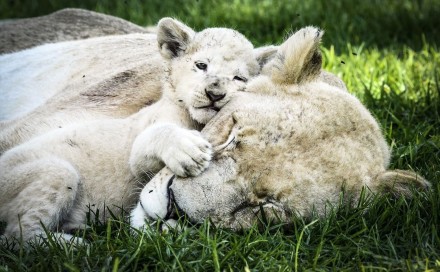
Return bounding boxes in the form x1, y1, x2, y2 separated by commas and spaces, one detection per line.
0, 0, 440, 52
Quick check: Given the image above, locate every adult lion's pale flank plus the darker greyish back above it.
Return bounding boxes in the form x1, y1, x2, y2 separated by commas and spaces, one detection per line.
0, 9, 160, 154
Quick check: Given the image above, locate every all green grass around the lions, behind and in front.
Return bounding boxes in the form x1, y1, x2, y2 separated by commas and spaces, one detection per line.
0, 0, 440, 271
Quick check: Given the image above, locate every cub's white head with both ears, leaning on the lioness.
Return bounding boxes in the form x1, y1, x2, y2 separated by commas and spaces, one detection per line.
157, 18, 276, 124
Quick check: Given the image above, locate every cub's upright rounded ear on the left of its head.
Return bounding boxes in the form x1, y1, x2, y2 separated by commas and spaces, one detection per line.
157, 18, 195, 59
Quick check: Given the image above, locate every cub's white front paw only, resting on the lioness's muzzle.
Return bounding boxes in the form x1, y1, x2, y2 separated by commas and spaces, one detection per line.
161, 128, 212, 177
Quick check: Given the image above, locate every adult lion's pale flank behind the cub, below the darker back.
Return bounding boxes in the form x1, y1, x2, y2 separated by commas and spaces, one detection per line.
0, 34, 165, 154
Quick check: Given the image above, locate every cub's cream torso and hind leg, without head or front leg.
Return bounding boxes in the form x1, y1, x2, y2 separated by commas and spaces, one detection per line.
0, 99, 192, 238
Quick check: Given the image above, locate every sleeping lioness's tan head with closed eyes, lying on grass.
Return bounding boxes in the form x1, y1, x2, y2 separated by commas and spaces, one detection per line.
131, 27, 430, 229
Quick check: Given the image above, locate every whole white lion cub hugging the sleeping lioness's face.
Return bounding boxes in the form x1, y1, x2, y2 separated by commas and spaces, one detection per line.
0, 18, 274, 240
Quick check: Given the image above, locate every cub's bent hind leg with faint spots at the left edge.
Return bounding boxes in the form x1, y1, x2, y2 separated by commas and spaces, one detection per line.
0, 153, 80, 241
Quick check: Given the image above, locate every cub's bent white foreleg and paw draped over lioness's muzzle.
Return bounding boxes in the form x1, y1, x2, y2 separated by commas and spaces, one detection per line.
130, 123, 212, 177
